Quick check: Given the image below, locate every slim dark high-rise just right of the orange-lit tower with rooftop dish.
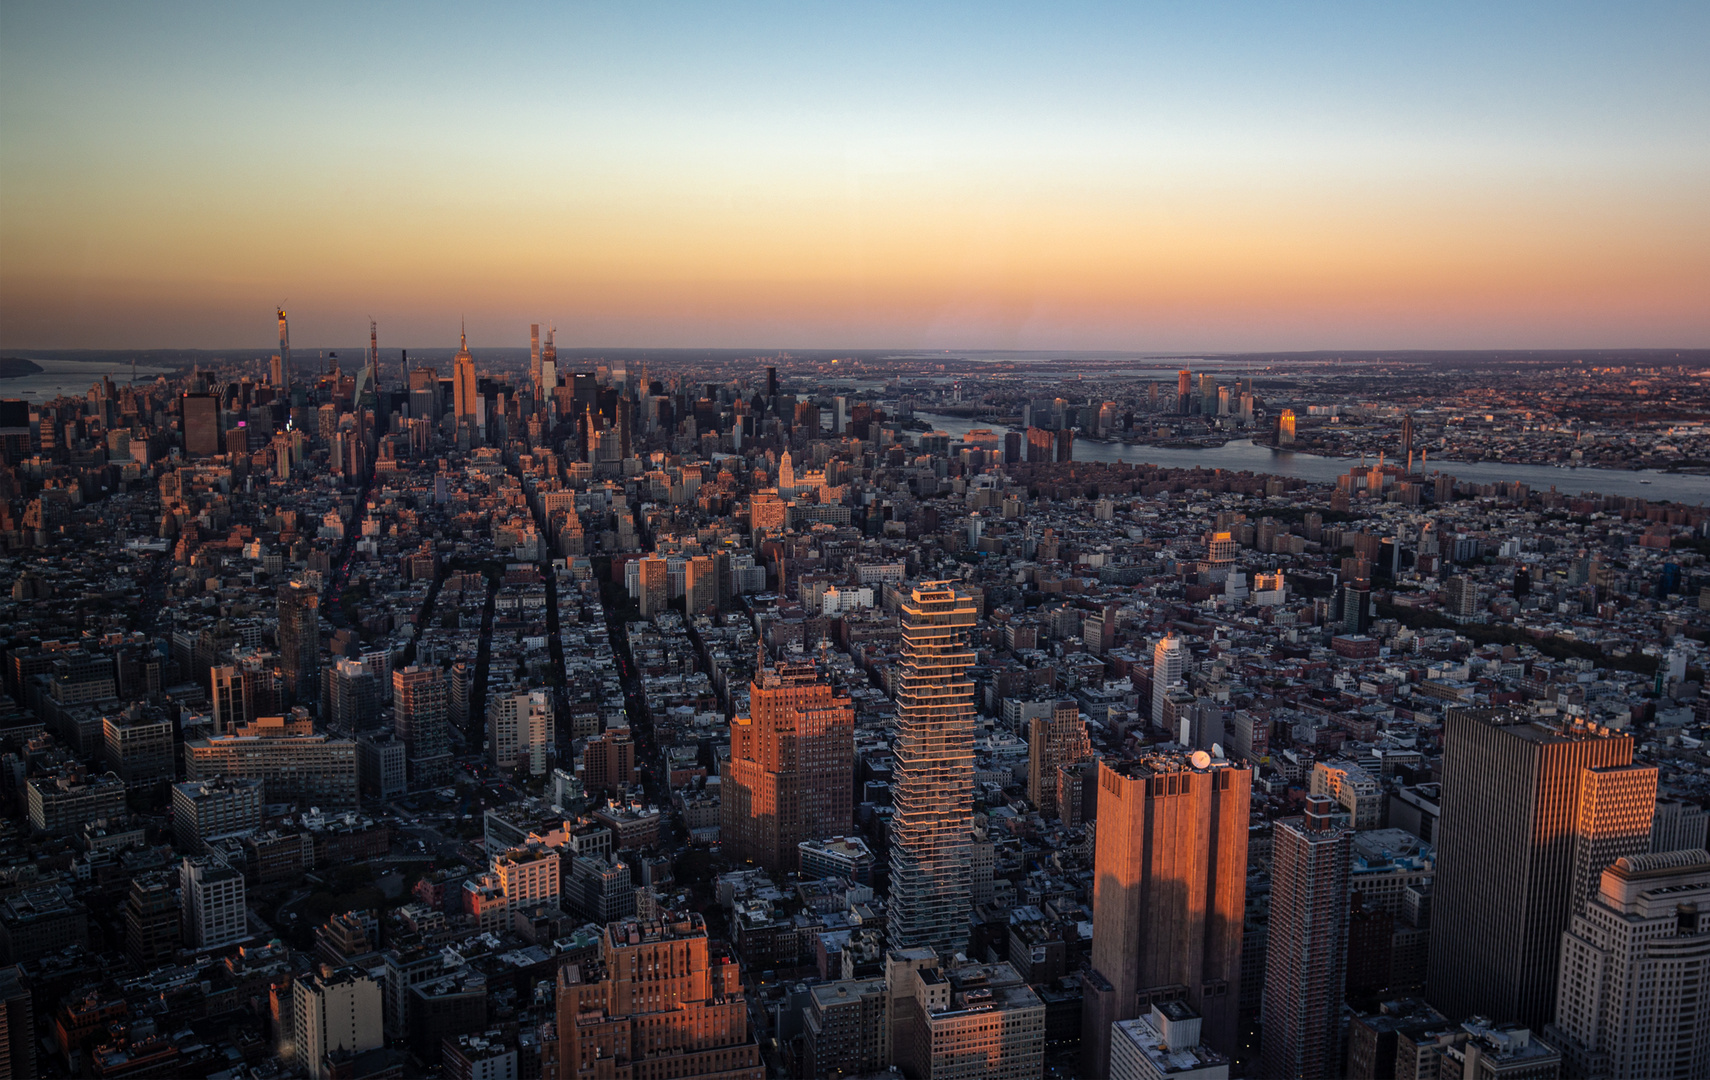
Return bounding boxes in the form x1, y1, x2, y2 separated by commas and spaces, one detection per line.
1260, 795, 1354, 1080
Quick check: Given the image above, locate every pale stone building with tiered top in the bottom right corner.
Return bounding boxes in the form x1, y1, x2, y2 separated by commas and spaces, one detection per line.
1546, 849, 1710, 1078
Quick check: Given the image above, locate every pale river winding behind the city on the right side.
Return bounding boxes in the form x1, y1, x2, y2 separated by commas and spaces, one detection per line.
915, 412, 1710, 506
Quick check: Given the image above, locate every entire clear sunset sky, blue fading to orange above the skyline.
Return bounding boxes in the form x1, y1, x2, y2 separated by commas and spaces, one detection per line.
0, 0, 1710, 355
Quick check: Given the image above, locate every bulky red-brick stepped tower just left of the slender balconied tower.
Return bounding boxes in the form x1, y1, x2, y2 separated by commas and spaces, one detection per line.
718, 652, 855, 873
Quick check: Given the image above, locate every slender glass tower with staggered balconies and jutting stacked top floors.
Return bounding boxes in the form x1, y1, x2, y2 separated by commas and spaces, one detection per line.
887, 581, 976, 955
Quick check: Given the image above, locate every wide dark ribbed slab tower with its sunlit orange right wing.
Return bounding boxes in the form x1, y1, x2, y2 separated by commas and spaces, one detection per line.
1426, 709, 1655, 1030
